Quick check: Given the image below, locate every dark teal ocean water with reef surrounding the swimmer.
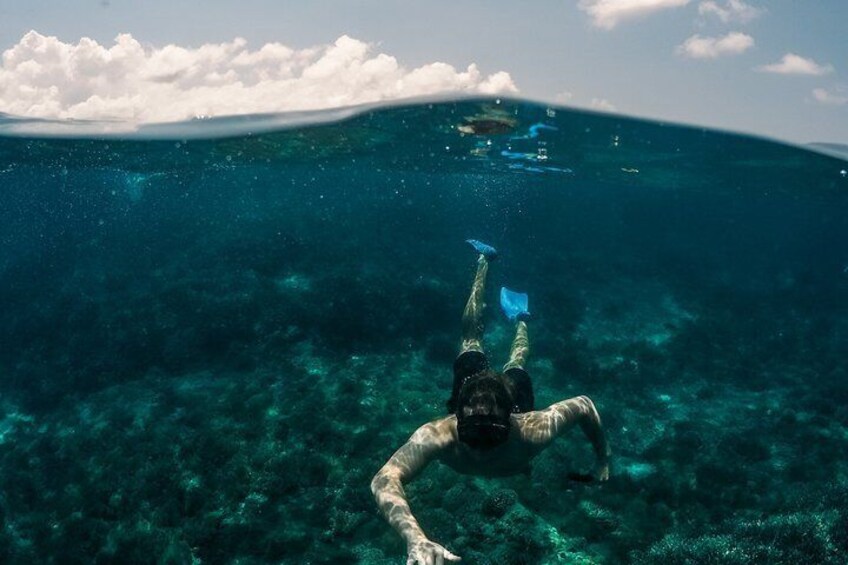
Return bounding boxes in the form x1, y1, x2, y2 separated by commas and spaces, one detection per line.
0, 99, 848, 565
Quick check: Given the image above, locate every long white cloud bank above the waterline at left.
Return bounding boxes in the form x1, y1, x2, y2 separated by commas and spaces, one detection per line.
0, 31, 518, 123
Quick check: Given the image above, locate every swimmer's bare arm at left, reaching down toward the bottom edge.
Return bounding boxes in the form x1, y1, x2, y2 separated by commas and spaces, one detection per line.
371, 418, 459, 565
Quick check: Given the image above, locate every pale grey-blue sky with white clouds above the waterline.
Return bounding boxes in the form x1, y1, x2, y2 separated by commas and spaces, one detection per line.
0, 0, 848, 143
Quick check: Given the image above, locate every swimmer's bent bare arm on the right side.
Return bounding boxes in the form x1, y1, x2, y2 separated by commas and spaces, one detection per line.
521, 396, 610, 481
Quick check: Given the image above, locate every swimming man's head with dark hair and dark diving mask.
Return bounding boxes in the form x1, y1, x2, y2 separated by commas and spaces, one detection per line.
451, 371, 513, 449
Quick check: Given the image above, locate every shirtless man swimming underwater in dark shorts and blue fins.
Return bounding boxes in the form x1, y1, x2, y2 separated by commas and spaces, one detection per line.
371, 240, 610, 565
